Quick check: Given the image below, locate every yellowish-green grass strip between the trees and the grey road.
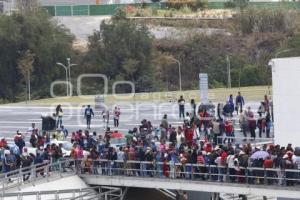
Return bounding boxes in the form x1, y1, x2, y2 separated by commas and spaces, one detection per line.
8, 86, 269, 106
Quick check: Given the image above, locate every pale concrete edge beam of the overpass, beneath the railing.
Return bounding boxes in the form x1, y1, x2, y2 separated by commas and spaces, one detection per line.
80, 174, 300, 199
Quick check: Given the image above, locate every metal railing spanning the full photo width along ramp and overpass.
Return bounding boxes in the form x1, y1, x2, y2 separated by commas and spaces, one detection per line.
0, 159, 300, 197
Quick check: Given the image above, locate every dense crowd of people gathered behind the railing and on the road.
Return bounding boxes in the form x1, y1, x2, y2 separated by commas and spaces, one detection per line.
0, 93, 300, 188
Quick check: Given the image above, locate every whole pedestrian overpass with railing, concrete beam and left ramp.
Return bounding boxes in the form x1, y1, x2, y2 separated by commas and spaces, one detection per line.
0, 160, 300, 200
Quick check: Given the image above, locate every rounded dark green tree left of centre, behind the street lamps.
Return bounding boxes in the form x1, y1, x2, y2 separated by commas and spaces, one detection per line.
86, 10, 153, 91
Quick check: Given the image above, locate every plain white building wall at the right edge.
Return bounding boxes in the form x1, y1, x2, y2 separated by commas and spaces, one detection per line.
270, 57, 300, 146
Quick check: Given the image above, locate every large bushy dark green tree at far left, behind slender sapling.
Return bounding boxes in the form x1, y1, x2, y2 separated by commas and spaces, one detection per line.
0, 9, 74, 101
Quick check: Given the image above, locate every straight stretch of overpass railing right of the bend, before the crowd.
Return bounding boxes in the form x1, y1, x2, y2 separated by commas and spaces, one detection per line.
76, 160, 300, 186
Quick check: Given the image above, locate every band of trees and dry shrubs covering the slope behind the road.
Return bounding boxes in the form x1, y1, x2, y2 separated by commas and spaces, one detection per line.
0, 0, 300, 102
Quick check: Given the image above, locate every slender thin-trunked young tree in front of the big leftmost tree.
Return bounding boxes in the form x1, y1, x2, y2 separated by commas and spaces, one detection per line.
18, 50, 34, 101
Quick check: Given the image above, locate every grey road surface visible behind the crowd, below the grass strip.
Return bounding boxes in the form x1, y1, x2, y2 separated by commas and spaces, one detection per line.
0, 102, 272, 145
